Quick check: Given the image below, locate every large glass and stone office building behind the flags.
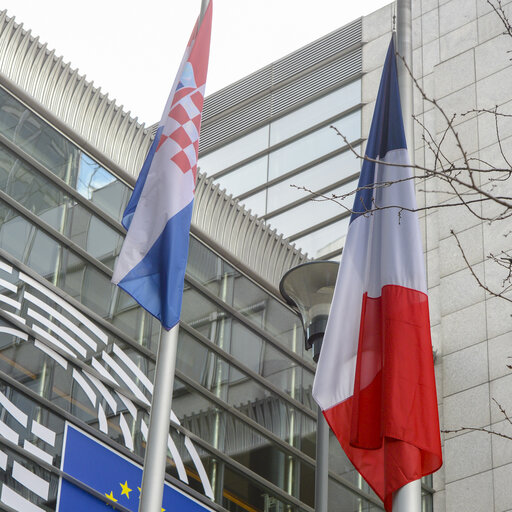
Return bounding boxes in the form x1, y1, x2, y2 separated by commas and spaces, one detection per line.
0, 0, 512, 512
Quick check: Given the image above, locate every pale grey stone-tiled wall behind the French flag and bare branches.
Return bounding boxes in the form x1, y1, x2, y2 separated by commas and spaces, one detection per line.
363, 0, 512, 512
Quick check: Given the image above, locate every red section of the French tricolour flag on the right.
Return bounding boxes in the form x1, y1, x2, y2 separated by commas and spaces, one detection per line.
324, 285, 442, 512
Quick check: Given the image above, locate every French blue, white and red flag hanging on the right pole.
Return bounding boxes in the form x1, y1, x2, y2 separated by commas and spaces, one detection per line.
313, 41, 442, 512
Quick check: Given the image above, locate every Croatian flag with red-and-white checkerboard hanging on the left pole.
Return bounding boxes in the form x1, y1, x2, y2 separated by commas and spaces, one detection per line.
112, 1, 212, 329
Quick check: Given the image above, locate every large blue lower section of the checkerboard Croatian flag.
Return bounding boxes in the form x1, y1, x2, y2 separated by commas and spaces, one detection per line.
118, 201, 193, 329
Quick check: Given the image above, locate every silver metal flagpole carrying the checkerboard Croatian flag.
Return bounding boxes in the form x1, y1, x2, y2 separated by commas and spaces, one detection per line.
139, 4, 209, 512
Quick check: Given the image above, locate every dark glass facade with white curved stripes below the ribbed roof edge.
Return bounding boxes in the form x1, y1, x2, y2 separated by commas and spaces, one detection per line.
0, 84, 428, 512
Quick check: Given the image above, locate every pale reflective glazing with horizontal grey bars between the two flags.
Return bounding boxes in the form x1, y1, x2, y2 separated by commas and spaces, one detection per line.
199, 79, 361, 258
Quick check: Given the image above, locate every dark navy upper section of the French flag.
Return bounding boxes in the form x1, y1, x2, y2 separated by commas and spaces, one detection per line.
350, 38, 407, 222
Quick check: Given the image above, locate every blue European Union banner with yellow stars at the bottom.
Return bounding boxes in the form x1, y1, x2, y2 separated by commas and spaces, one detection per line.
57, 424, 211, 512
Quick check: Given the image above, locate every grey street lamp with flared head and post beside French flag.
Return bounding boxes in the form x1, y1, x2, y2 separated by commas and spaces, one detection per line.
279, 261, 339, 512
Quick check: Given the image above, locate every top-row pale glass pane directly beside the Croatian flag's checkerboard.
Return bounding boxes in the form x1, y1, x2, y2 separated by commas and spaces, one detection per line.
199, 125, 269, 176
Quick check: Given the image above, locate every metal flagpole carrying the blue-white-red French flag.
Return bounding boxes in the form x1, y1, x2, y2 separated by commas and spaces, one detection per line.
393, 0, 421, 512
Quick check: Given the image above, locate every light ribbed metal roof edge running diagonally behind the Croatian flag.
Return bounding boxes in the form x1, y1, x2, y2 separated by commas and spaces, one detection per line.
0, 11, 306, 291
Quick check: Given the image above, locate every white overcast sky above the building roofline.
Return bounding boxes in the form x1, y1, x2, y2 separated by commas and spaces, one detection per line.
0, 0, 391, 124
